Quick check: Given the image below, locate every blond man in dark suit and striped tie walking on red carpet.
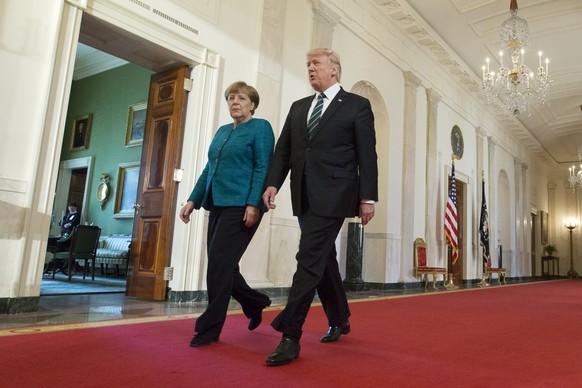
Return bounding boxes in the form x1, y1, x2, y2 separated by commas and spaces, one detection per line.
263, 49, 378, 365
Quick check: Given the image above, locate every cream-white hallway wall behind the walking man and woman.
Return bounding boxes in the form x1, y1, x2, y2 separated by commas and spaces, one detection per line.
0, 0, 582, 310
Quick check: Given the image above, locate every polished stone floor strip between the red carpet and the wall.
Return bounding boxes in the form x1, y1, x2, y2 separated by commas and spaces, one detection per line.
0, 280, 540, 329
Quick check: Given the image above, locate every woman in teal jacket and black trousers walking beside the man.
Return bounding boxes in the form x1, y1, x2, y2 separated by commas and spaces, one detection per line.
180, 81, 275, 347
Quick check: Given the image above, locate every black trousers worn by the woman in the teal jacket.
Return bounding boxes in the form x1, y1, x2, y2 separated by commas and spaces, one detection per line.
195, 206, 269, 338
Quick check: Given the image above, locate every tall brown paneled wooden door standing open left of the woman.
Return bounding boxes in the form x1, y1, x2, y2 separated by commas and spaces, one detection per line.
126, 66, 190, 300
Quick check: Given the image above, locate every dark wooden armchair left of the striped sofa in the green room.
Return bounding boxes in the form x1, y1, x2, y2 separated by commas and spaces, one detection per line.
53, 225, 101, 281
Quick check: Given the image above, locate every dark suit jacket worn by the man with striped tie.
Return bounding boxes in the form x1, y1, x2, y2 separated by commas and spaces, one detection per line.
266, 88, 378, 218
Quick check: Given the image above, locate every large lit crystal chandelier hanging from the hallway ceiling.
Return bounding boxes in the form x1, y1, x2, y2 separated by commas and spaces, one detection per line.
482, 0, 552, 116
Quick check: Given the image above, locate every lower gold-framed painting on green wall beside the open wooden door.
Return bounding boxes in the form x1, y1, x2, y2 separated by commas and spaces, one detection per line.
113, 162, 140, 218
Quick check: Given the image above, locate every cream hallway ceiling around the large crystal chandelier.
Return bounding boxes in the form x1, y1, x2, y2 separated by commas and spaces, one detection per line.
392, 0, 582, 164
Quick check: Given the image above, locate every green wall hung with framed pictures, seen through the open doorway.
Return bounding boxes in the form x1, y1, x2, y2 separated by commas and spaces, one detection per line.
61, 64, 152, 236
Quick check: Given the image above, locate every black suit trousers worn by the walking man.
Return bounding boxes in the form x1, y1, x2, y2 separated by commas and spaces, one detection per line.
271, 209, 350, 339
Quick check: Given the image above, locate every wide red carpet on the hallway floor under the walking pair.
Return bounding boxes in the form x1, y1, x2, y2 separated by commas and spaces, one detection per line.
0, 280, 582, 387
